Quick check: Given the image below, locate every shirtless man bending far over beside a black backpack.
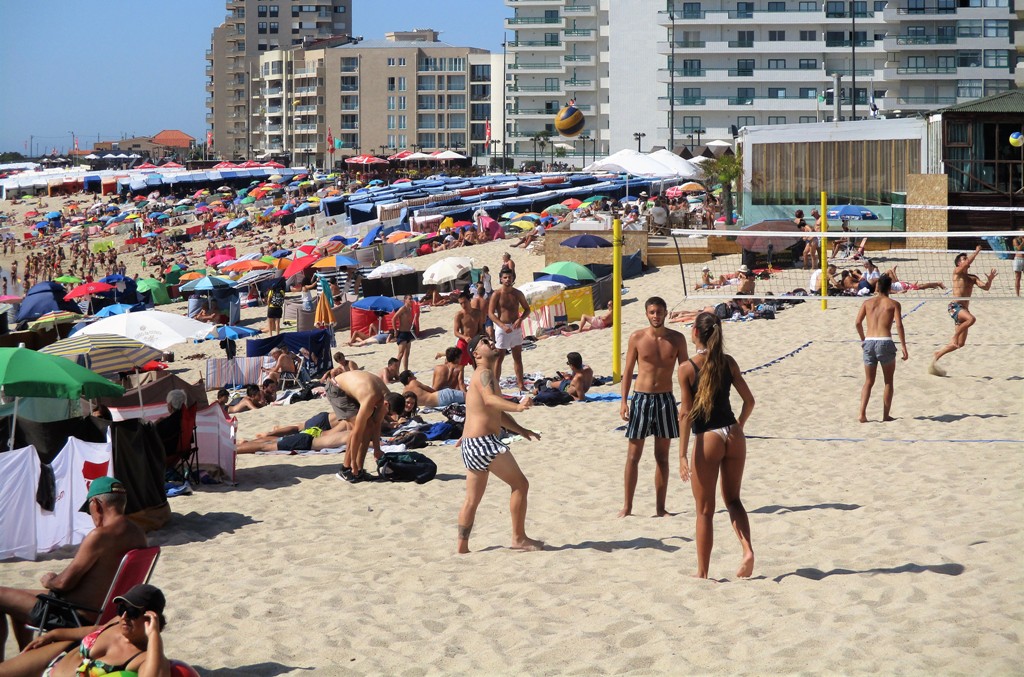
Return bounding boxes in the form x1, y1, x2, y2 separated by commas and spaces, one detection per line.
327, 371, 390, 482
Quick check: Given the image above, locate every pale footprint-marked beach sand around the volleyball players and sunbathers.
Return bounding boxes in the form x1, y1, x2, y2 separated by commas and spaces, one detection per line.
0, 192, 1024, 676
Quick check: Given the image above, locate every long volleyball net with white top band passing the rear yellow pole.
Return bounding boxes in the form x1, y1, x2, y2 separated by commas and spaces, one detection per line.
670, 229, 1024, 302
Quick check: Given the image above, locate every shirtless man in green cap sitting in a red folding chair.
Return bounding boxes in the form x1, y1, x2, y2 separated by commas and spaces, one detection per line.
0, 477, 146, 661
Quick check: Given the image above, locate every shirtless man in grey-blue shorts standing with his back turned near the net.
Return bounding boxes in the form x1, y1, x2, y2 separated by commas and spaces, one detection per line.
857, 274, 909, 423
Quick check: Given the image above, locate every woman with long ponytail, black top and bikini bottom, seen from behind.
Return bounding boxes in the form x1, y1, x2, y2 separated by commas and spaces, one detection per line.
679, 312, 754, 579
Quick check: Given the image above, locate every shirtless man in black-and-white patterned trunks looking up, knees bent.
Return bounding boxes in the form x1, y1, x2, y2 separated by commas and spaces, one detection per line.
458, 334, 544, 554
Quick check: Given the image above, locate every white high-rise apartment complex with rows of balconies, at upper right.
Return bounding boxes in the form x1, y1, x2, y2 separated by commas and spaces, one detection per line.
505, 0, 1021, 157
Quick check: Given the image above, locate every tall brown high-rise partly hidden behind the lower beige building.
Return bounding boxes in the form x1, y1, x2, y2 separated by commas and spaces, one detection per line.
206, 0, 352, 159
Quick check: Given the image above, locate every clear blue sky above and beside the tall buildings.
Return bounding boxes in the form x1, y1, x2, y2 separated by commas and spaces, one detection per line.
0, 0, 512, 153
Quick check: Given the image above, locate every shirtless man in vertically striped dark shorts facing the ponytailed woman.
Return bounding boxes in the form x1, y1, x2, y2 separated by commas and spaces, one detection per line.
618, 296, 687, 517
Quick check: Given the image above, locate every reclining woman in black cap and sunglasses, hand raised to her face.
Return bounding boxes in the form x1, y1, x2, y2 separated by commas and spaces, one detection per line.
0, 585, 171, 677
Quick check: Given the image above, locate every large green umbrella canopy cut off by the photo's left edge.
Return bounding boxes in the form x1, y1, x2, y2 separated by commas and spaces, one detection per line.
0, 348, 125, 399
